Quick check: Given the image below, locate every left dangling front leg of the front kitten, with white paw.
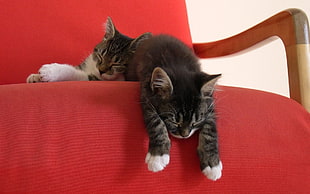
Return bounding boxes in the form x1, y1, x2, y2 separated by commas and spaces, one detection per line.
142, 101, 171, 172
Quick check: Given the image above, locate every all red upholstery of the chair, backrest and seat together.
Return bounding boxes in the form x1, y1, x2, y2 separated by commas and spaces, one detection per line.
0, 0, 310, 193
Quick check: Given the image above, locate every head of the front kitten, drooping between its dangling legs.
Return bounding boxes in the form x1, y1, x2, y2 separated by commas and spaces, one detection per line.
150, 67, 220, 138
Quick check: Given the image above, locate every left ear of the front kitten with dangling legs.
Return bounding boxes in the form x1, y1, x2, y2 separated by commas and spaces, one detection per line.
151, 67, 173, 100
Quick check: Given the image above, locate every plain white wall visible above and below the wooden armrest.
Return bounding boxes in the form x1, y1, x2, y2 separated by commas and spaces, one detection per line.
186, 0, 310, 96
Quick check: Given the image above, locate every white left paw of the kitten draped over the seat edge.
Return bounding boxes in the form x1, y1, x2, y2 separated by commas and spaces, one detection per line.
145, 153, 170, 172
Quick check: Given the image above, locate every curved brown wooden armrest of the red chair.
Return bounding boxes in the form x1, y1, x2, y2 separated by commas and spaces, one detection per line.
193, 9, 310, 112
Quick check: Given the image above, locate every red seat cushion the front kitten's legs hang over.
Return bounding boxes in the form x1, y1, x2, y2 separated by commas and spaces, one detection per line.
0, 82, 310, 193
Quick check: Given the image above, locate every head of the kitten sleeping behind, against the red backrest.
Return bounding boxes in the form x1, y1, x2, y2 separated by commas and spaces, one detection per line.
93, 17, 151, 80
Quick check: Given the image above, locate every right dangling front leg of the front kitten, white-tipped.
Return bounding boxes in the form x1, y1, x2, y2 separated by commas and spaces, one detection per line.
197, 121, 223, 181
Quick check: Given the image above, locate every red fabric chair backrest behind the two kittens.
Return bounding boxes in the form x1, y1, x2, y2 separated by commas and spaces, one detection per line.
0, 0, 191, 84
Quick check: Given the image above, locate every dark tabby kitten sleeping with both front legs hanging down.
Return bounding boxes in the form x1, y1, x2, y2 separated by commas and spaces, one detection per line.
130, 35, 222, 180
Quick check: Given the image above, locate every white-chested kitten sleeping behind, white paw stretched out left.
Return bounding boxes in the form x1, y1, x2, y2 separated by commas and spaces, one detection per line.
27, 17, 151, 83
